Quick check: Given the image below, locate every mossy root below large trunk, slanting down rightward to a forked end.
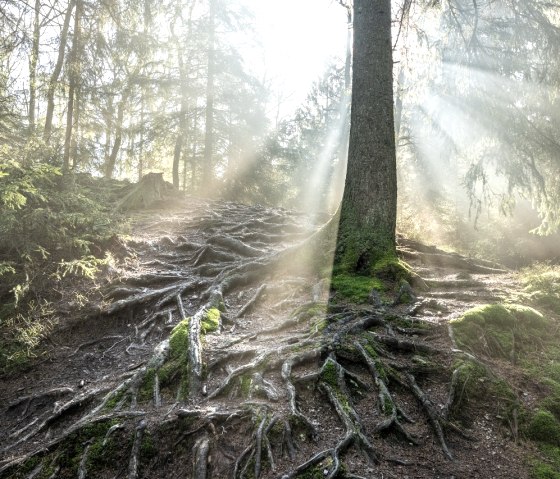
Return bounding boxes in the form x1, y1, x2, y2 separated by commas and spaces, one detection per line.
354, 341, 418, 445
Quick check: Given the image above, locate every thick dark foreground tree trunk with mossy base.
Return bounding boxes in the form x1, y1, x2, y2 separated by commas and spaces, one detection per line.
335, 0, 397, 274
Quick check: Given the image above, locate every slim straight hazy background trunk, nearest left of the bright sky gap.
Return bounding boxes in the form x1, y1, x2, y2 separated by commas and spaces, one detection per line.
202, 0, 216, 190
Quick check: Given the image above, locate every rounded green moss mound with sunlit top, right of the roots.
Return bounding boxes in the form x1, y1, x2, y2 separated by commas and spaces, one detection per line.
451, 304, 551, 359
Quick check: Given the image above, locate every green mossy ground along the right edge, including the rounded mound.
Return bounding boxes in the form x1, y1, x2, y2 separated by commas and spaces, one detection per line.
451, 284, 560, 479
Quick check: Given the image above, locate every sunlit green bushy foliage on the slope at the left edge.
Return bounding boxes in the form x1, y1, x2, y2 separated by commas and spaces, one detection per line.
0, 160, 127, 373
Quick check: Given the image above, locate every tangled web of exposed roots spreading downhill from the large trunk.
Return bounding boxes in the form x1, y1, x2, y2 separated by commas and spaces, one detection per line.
0, 201, 508, 479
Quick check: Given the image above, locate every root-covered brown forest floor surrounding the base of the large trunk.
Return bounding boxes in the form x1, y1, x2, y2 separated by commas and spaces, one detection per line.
0, 198, 545, 479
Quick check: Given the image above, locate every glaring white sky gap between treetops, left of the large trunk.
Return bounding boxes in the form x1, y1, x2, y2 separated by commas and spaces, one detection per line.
243, 0, 348, 116
